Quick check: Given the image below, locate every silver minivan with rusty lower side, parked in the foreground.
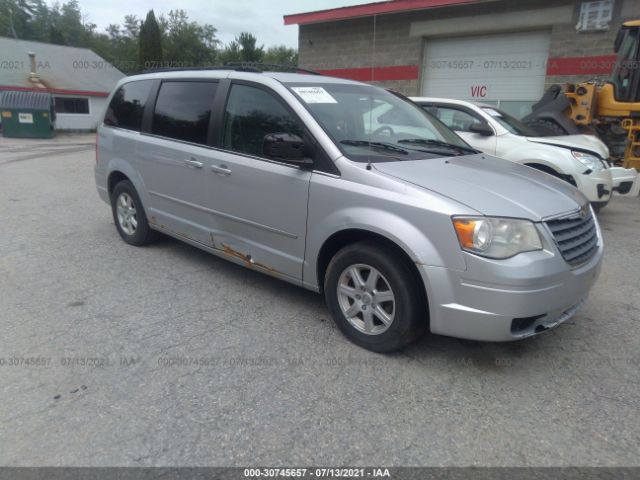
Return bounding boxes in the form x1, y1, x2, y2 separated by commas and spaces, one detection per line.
95, 69, 603, 352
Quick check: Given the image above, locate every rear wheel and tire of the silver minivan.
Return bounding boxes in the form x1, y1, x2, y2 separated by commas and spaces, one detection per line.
111, 180, 159, 246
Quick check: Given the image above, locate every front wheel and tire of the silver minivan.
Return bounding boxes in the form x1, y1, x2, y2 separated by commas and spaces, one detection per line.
324, 241, 428, 353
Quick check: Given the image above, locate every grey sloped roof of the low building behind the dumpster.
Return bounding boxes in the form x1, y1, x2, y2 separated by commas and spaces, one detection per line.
0, 37, 125, 96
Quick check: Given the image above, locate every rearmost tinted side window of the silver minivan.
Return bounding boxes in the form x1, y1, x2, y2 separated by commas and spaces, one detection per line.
104, 80, 152, 132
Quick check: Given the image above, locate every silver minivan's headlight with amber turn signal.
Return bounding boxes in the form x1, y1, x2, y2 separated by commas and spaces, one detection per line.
453, 217, 542, 258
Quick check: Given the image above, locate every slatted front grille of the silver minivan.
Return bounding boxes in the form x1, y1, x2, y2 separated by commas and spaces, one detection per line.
546, 206, 598, 267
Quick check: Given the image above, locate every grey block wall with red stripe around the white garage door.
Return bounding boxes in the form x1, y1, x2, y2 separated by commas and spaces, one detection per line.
299, 0, 640, 95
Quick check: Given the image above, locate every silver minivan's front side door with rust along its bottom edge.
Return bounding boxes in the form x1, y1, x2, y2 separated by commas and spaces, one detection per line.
208, 81, 311, 280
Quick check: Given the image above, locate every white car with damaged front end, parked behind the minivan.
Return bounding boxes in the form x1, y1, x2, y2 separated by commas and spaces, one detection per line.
411, 97, 638, 209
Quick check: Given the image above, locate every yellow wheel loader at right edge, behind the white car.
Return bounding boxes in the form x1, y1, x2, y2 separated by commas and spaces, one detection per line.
522, 20, 640, 177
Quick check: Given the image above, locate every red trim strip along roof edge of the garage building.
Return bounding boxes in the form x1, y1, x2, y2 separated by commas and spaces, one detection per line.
284, 0, 487, 25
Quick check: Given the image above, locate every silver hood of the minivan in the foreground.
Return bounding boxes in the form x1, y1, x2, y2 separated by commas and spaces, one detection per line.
373, 154, 587, 221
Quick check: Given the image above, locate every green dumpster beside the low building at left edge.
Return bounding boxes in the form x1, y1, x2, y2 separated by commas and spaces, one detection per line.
0, 90, 55, 138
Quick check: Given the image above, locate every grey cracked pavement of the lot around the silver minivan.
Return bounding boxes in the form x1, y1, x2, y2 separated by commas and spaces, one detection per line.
0, 136, 640, 466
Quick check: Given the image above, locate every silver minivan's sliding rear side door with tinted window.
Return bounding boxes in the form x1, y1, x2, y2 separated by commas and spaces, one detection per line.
138, 79, 218, 246
